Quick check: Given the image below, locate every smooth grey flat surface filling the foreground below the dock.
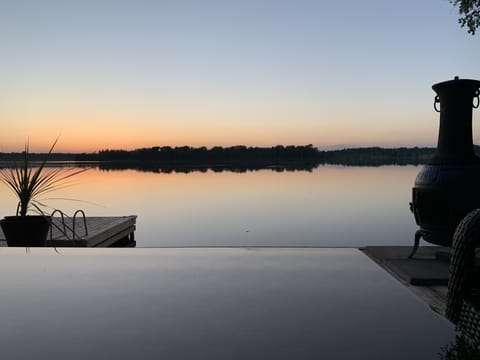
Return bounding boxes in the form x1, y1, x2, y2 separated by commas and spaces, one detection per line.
0, 248, 454, 360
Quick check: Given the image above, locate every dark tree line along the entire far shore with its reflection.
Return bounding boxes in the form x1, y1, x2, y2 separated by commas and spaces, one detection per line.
0, 144, 480, 168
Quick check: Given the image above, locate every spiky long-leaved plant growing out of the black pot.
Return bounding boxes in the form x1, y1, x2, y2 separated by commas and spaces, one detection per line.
0, 138, 87, 216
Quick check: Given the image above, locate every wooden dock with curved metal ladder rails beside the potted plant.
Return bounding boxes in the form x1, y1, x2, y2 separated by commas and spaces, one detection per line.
0, 215, 137, 247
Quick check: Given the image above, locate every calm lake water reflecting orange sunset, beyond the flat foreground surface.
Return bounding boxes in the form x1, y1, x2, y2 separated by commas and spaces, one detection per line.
0, 166, 419, 247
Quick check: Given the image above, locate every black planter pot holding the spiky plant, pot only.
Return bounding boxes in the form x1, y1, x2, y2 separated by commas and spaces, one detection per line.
0, 215, 52, 247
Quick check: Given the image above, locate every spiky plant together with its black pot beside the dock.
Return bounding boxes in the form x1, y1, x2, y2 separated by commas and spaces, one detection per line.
0, 138, 87, 247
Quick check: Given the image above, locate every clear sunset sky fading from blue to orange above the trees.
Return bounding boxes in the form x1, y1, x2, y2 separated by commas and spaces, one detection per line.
0, 0, 480, 152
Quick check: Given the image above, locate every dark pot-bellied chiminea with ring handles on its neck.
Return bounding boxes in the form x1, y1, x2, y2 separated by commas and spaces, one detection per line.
409, 77, 480, 257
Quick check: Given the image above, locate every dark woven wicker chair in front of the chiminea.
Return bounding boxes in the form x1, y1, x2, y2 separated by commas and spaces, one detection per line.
446, 209, 480, 346
